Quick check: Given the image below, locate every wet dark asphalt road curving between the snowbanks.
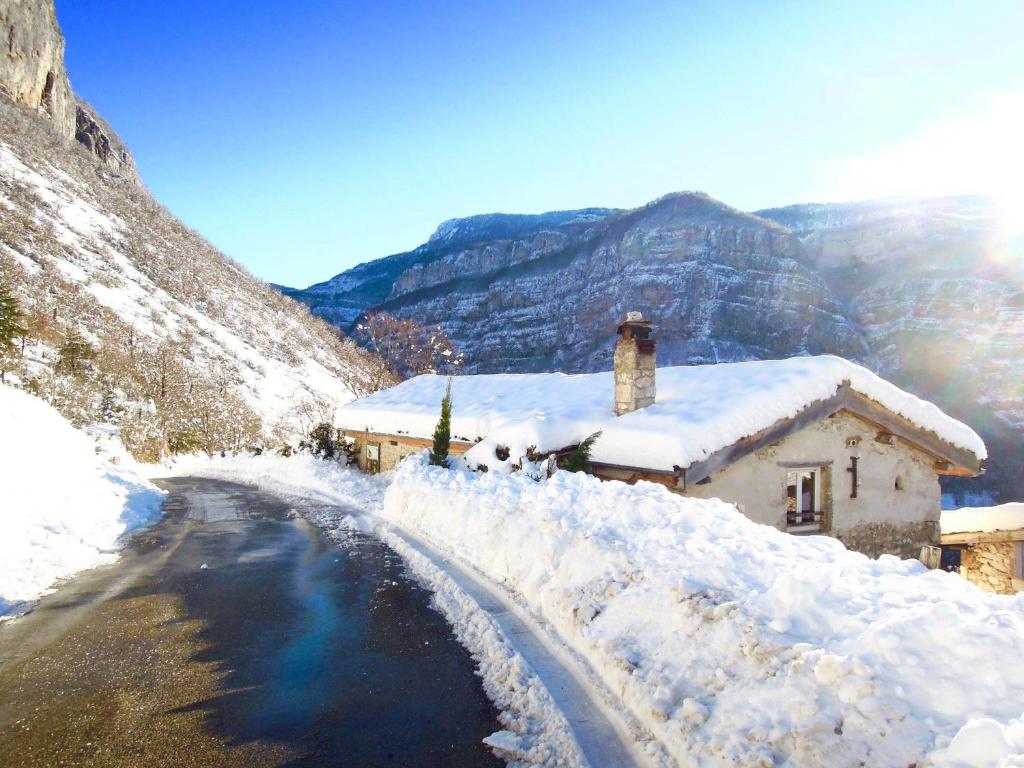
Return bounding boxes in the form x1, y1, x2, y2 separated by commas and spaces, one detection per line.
0, 478, 502, 768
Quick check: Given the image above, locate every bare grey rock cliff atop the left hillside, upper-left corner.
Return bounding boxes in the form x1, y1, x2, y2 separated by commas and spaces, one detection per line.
0, 0, 136, 180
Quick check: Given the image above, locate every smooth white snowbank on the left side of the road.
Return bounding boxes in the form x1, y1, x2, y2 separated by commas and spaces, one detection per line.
0, 384, 163, 617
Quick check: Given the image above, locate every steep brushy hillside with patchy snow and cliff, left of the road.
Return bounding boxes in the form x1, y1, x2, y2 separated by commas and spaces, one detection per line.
0, 2, 380, 458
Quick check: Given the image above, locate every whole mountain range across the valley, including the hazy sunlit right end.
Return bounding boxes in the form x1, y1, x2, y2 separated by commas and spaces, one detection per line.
286, 193, 1024, 496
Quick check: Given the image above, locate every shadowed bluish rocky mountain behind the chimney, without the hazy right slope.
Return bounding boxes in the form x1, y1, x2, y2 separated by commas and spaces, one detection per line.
293, 194, 867, 372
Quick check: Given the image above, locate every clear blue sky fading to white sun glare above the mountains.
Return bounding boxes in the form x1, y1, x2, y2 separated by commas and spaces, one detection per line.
57, 0, 1024, 286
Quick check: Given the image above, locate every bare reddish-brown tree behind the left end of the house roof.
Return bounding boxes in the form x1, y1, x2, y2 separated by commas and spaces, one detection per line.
355, 312, 463, 379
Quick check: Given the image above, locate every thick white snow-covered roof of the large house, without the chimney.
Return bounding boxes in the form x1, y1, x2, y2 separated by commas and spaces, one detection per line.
336, 355, 986, 471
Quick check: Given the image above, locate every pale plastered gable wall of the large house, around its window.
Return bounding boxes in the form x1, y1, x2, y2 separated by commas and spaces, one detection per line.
686, 412, 941, 557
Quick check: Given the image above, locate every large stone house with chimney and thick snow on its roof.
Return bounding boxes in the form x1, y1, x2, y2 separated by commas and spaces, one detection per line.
337, 313, 985, 557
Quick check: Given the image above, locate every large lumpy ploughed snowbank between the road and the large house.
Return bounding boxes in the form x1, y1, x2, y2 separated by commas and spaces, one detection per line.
383, 459, 1024, 766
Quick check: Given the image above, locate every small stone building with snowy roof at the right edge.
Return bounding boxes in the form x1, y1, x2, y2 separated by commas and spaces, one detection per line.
941, 502, 1024, 595
